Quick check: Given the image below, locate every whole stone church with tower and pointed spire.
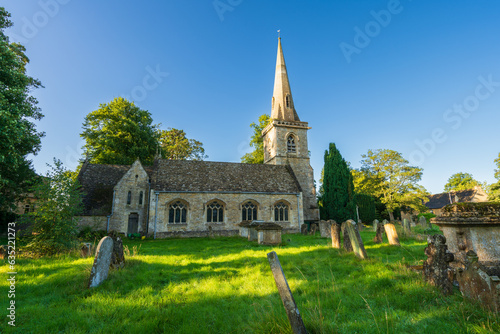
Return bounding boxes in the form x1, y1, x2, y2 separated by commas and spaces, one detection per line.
78, 39, 319, 238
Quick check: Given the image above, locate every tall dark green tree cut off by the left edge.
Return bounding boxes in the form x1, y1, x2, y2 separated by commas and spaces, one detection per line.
0, 7, 44, 211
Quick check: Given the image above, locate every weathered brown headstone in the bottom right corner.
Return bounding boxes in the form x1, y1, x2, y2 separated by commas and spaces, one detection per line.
457, 251, 500, 312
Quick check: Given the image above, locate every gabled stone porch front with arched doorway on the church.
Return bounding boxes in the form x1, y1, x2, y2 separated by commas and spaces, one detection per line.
109, 161, 149, 234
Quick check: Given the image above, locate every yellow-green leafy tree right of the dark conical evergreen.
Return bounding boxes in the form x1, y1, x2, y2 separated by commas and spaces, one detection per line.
360, 149, 428, 220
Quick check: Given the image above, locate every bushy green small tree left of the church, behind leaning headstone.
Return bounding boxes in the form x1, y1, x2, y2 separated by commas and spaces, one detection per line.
21, 159, 82, 255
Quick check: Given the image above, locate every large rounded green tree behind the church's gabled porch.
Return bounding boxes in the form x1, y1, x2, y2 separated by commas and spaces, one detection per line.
80, 97, 158, 165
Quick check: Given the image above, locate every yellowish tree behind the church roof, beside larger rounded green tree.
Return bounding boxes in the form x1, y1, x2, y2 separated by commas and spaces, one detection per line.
159, 128, 208, 160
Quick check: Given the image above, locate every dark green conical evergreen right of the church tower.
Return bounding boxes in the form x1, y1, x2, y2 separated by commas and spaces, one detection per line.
319, 143, 356, 223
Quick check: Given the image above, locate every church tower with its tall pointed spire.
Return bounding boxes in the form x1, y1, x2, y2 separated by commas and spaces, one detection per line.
262, 38, 319, 221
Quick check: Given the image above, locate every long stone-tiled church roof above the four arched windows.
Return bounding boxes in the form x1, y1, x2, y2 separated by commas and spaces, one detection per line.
151, 159, 301, 193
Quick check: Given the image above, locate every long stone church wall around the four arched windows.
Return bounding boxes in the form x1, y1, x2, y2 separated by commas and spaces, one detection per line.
148, 190, 303, 238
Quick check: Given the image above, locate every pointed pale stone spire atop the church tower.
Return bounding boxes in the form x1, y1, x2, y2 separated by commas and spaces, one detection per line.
271, 38, 300, 122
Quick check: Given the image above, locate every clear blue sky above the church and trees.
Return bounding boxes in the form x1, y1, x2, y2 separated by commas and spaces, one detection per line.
2, 0, 500, 193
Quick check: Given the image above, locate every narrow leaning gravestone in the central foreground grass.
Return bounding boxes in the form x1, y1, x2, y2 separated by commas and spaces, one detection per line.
267, 252, 307, 334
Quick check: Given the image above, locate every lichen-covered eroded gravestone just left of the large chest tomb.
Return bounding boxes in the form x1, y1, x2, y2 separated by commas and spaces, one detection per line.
423, 234, 453, 295
